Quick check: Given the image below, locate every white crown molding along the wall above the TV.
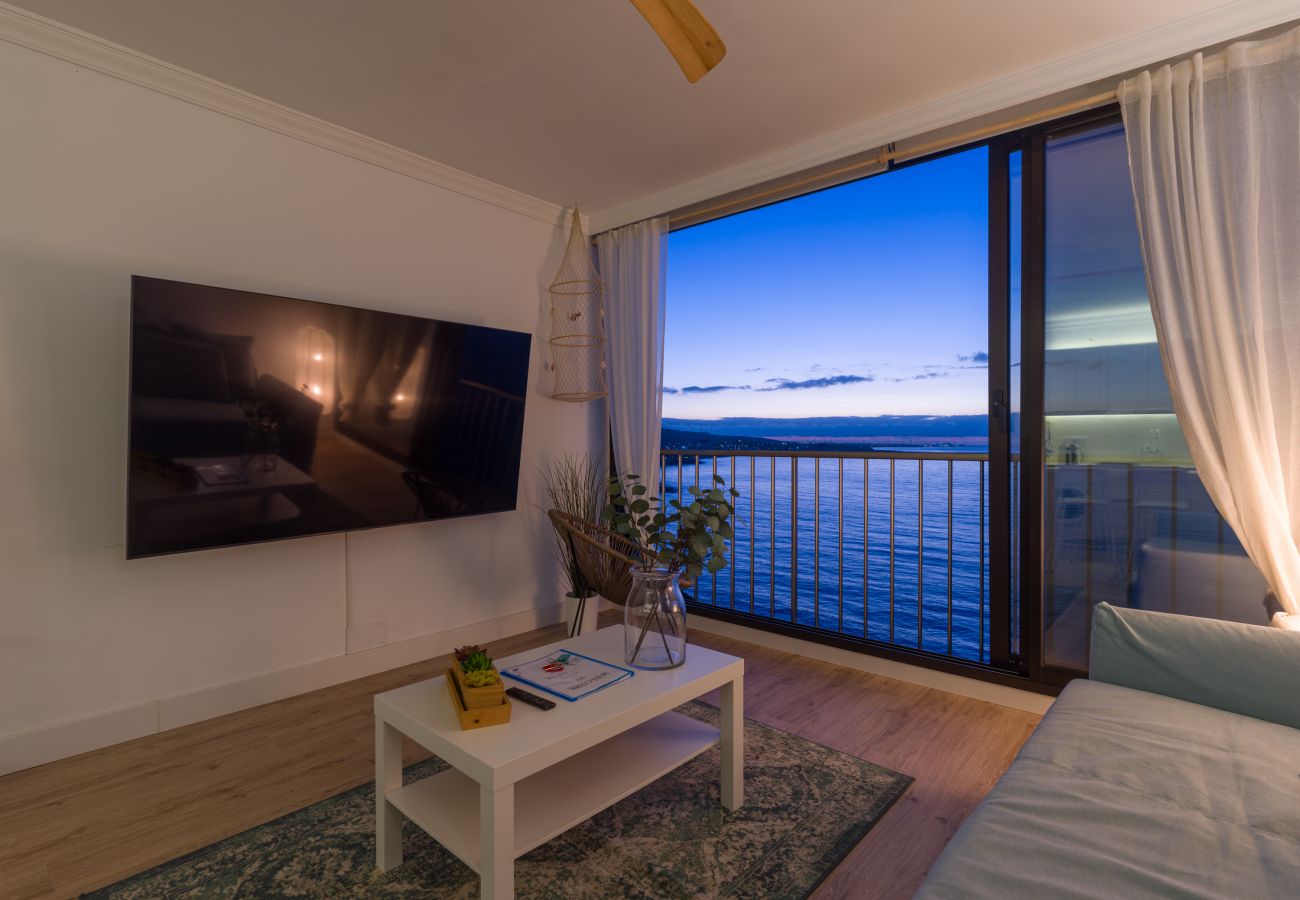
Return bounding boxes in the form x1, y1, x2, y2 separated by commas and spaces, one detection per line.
0, 1, 566, 228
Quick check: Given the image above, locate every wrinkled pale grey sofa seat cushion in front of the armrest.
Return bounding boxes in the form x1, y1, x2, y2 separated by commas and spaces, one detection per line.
917, 680, 1300, 900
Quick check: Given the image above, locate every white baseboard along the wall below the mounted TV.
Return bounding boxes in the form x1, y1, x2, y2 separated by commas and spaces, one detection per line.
0, 605, 564, 775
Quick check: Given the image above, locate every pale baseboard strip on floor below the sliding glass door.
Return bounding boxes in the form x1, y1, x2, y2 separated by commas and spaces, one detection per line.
688, 615, 1054, 715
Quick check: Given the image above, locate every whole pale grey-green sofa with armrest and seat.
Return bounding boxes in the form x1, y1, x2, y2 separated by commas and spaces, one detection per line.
917, 603, 1300, 900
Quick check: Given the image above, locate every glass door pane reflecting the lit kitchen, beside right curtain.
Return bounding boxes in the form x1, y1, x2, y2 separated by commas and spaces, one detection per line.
1041, 117, 1268, 670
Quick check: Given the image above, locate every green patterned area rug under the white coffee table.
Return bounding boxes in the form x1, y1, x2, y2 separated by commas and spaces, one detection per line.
86, 701, 911, 900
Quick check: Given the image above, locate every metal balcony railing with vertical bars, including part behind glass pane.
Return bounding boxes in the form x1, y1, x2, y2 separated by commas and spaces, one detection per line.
660, 449, 1268, 668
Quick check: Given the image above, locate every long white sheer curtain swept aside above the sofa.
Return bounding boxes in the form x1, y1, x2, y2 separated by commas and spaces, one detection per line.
1119, 29, 1300, 629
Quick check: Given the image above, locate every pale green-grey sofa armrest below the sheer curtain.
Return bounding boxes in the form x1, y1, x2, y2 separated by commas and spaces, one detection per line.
1088, 603, 1300, 728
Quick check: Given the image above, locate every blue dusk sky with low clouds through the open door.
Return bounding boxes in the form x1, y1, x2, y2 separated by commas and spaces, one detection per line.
663, 148, 988, 419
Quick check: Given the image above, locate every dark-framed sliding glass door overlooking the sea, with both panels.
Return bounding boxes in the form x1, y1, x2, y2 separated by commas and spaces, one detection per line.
662, 103, 1268, 684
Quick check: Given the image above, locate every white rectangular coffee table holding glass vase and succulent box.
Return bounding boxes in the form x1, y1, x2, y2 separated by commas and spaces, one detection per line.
374, 626, 745, 900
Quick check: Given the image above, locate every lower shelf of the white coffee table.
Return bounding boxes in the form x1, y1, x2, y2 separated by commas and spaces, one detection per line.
385, 713, 720, 874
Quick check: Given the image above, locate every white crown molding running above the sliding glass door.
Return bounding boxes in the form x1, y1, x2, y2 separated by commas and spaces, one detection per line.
592, 0, 1300, 234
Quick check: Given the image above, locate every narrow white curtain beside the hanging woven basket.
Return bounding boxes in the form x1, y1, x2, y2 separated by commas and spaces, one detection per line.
595, 217, 668, 497
